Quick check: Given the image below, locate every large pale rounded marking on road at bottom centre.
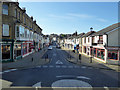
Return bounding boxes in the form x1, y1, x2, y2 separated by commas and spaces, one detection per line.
52, 79, 92, 89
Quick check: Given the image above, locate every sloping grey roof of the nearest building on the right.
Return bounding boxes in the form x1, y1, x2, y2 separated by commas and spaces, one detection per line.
92, 22, 120, 36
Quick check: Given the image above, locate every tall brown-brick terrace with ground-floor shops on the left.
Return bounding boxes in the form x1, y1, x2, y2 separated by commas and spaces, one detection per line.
0, 2, 42, 62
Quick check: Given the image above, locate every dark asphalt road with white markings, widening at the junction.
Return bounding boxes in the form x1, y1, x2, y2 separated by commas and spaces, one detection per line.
2, 47, 118, 87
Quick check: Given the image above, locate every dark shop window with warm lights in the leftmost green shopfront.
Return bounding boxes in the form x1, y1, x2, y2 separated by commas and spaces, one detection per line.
2, 45, 10, 59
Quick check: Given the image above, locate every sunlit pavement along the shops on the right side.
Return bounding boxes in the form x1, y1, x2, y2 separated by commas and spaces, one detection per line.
62, 48, 120, 72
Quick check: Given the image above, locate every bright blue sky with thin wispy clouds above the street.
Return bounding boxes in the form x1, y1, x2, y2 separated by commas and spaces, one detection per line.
19, 2, 118, 35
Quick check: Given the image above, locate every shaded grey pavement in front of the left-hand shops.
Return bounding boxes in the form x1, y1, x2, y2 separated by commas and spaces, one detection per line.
2, 48, 49, 71
